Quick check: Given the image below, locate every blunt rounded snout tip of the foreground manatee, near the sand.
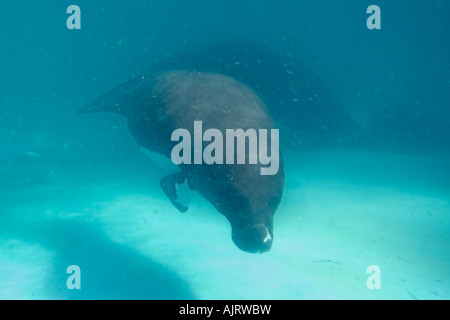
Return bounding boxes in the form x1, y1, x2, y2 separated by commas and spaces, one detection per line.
232, 224, 273, 253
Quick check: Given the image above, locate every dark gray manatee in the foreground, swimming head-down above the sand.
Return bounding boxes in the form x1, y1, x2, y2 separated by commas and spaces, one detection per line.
78, 71, 284, 252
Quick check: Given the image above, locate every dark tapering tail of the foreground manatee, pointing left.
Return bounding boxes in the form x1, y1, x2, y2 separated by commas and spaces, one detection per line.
77, 75, 154, 117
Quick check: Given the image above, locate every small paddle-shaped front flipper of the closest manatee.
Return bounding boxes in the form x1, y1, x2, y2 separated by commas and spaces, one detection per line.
160, 172, 192, 212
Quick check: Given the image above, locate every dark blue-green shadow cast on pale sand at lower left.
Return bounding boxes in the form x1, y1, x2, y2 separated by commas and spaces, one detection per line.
1, 219, 195, 300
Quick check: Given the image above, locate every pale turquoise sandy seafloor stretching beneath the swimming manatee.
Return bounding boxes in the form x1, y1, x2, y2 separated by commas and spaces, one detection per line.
0, 150, 450, 299
